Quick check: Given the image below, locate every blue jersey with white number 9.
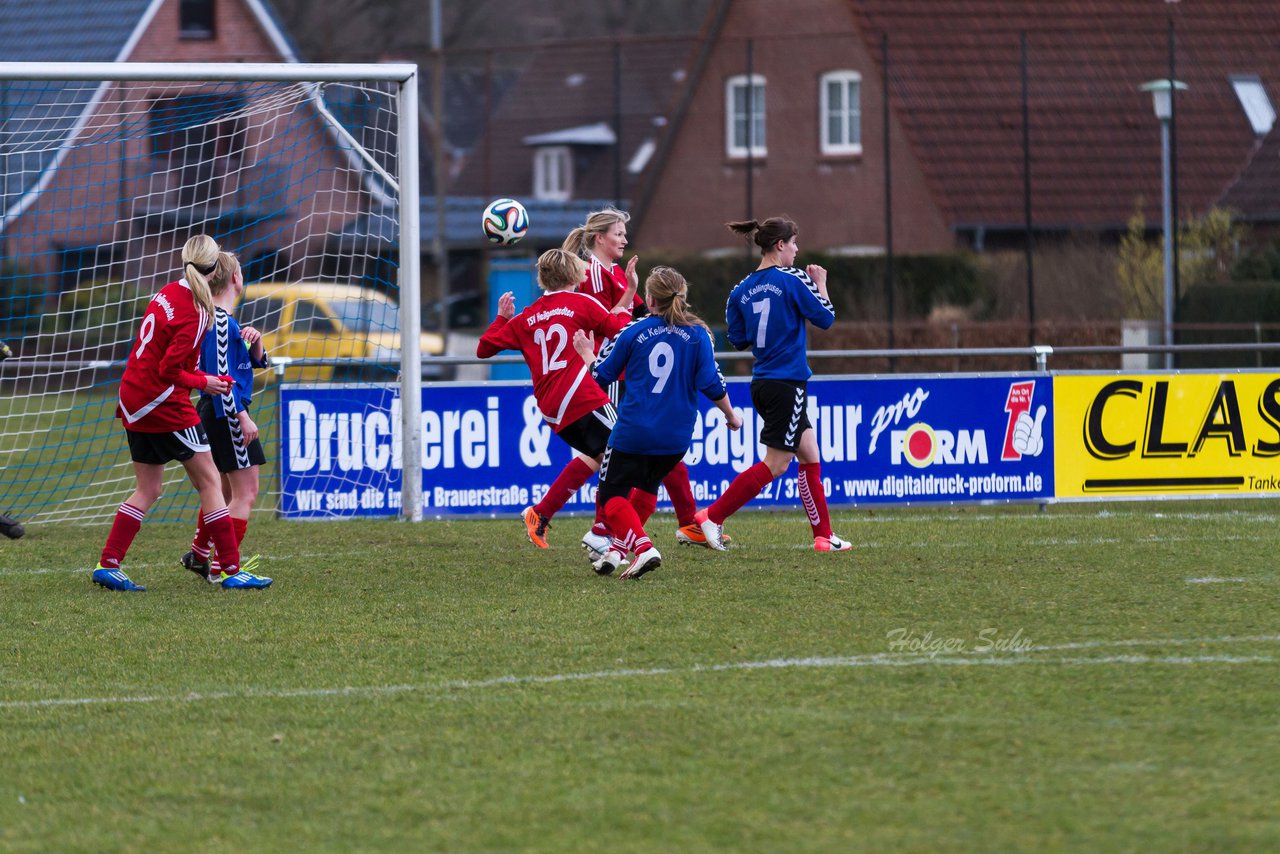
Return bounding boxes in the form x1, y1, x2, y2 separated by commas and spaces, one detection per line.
593, 315, 726, 455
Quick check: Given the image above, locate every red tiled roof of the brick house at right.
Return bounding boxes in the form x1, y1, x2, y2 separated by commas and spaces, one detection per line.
846, 0, 1280, 228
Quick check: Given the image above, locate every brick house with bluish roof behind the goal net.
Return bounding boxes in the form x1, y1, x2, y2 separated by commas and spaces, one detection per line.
0, 0, 367, 291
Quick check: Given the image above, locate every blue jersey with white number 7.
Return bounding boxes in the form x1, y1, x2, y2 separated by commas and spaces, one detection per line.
724, 266, 836, 382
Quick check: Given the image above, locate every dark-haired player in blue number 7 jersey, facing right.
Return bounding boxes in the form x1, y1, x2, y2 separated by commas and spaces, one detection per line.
698, 216, 852, 552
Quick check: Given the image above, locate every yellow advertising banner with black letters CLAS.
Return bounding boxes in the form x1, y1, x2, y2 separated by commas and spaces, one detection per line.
1053, 373, 1280, 498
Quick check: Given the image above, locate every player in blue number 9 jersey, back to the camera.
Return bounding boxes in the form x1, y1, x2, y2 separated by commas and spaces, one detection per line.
573, 266, 742, 579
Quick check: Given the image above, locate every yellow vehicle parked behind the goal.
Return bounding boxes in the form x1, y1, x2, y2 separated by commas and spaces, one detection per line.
236, 282, 444, 383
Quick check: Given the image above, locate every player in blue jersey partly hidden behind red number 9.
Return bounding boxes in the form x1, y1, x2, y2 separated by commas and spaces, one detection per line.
182, 252, 271, 588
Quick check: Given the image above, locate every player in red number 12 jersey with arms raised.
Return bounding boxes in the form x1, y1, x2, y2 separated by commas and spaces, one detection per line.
476, 250, 635, 548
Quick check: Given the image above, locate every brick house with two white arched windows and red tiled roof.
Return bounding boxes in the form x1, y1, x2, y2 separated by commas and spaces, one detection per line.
632, 0, 1280, 252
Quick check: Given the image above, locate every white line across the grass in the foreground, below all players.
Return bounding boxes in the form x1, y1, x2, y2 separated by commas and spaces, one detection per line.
0, 635, 1280, 709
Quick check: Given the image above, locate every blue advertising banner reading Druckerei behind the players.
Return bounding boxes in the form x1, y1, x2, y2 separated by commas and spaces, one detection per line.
280, 375, 1053, 519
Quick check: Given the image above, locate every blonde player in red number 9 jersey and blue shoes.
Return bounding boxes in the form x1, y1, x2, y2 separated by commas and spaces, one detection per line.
93, 234, 271, 592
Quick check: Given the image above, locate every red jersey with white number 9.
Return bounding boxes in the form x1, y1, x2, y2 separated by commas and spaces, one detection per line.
115, 279, 209, 433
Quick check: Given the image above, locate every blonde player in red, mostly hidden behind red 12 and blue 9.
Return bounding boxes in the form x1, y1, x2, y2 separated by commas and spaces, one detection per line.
534, 207, 707, 561
